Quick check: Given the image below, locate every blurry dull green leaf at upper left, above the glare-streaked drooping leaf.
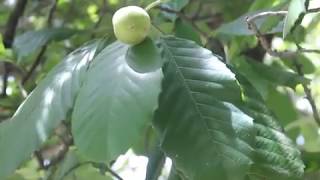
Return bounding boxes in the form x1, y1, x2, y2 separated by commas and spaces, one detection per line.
13, 28, 79, 60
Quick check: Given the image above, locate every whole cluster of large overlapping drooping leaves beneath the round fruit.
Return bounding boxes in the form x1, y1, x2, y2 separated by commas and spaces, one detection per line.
0, 37, 304, 180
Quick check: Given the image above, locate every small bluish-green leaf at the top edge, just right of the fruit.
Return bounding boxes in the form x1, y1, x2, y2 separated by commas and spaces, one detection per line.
161, 0, 189, 21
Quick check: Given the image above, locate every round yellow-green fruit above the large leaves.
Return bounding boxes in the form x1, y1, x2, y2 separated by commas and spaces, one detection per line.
112, 6, 151, 45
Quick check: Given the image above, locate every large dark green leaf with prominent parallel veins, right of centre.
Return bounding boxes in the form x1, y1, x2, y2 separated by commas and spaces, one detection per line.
154, 37, 254, 180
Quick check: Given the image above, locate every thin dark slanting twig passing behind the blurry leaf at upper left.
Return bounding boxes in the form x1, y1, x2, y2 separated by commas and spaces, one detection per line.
21, 0, 59, 85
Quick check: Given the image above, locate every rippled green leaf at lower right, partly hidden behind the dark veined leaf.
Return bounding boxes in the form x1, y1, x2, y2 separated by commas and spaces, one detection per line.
237, 70, 304, 180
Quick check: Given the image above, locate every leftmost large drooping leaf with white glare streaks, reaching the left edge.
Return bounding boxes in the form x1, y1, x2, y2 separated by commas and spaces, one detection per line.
0, 41, 99, 179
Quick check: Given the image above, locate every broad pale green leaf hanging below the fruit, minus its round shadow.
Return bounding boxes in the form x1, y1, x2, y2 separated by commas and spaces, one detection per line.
72, 42, 162, 162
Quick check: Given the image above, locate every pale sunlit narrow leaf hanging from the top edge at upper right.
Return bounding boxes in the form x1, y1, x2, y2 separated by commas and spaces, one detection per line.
283, 0, 309, 38
